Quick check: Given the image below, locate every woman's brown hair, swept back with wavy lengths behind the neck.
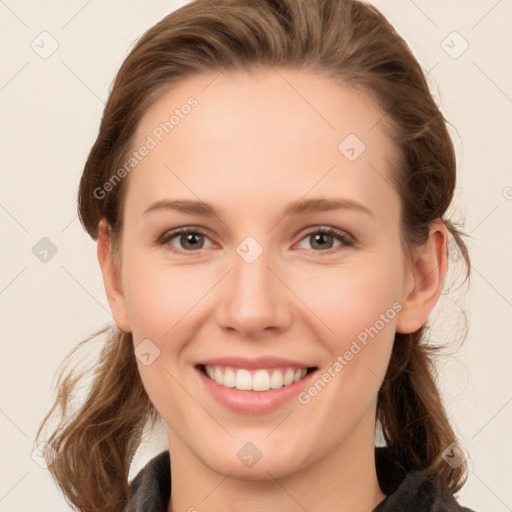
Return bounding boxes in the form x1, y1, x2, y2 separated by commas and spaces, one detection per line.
38, 0, 470, 512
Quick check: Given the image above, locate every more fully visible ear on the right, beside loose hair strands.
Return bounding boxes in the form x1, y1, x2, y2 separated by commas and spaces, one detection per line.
396, 219, 448, 334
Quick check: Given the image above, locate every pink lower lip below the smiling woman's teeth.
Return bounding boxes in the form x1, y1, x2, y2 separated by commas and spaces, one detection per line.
196, 368, 316, 414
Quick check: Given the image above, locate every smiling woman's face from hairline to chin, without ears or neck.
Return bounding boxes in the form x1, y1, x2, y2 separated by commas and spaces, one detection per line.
103, 69, 420, 479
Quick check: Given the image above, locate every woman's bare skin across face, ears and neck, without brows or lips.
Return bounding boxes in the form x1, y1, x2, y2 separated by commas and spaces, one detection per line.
98, 69, 447, 512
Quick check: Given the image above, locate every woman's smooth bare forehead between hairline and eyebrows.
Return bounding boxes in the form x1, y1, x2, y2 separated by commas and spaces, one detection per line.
126, 68, 396, 218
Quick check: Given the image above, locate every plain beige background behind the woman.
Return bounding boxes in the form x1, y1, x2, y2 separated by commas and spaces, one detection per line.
0, 0, 512, 512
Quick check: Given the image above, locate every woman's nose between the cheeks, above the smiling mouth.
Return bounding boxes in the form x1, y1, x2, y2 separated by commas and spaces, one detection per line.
215, 245, 293, 339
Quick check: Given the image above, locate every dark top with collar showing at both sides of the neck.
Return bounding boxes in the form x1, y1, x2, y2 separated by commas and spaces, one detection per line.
126, 447, 474, 512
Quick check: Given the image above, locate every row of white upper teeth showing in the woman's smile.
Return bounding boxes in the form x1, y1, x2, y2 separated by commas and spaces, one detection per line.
205, 365, 307, 391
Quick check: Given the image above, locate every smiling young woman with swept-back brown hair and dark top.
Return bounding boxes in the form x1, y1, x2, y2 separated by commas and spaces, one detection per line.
36, 0, 476, 512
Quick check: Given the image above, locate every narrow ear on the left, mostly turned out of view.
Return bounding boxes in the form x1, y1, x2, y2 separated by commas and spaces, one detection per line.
97, 219, 130, 332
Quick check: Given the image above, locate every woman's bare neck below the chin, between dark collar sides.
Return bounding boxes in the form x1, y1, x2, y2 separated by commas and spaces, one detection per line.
168, 408, 386, 512
